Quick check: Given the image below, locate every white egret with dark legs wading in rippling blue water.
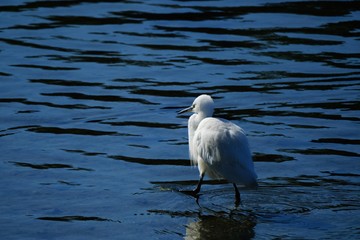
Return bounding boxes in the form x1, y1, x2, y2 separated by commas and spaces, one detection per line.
178, 94, 257, 205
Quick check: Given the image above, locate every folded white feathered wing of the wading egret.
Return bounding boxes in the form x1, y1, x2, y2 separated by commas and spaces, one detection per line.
194, 118, 256, 184
